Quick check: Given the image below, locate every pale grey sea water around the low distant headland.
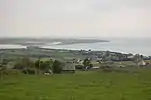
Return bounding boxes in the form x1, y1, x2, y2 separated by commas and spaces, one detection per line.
0, 38, 151, 56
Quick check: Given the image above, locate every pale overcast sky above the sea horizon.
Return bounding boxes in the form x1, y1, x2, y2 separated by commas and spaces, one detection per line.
0, 0, 151, 37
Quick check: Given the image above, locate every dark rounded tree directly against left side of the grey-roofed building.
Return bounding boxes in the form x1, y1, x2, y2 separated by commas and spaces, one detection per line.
52, 60, 62, 74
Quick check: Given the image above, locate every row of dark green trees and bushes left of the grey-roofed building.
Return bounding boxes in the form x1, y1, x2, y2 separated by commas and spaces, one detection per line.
0, 57, 63, 74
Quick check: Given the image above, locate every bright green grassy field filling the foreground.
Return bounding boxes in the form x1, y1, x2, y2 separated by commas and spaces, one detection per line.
0, 70, 151, 100
